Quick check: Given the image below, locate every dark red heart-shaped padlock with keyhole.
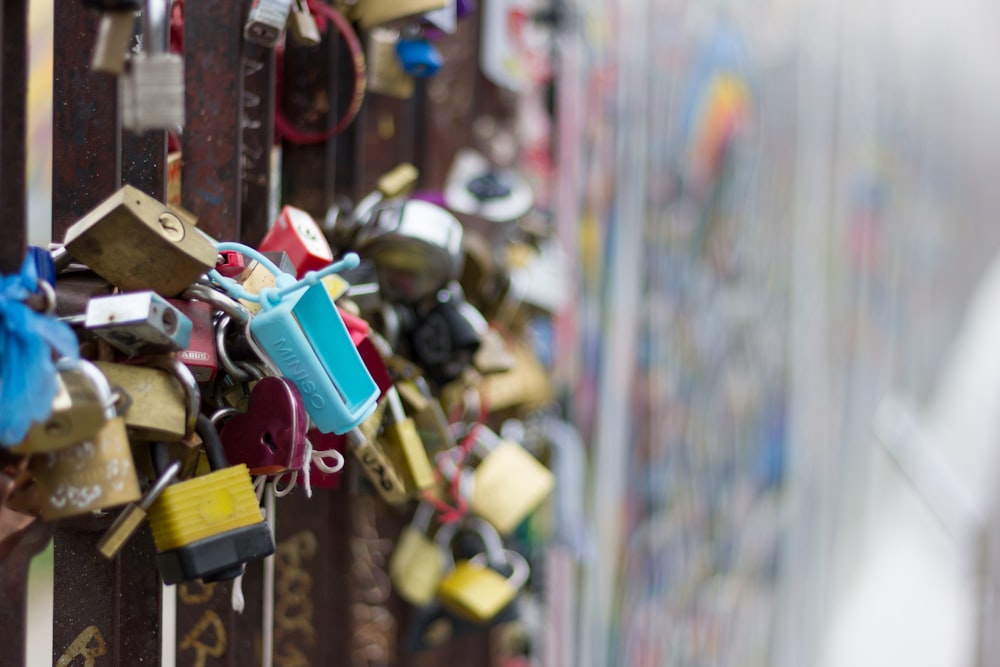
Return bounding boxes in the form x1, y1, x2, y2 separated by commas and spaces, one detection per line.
220, 376, 308, 475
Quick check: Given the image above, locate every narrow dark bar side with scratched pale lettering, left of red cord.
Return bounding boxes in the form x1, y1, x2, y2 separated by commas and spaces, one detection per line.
241, 43, 275, 246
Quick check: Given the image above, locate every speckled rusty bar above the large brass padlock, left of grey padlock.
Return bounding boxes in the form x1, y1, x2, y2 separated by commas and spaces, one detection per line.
52, 0, 121, 241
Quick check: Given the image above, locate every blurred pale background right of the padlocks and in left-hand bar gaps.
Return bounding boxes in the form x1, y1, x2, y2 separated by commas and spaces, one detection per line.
23, 0, 1000, 667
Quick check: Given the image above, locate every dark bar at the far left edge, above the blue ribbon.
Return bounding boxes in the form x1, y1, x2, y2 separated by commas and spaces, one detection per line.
0, 0, 28, 275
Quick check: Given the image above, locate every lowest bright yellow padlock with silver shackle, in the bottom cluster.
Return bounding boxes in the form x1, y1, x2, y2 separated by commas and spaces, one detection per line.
437, 520, 531, 623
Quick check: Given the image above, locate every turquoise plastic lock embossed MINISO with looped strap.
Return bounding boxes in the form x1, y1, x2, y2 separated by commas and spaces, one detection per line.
209, 242, 379, 434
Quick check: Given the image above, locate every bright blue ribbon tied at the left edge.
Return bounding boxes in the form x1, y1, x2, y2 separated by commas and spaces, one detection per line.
0, 256, 80, 446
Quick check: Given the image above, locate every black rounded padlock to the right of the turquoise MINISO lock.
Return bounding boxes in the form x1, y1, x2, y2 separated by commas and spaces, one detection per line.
409, 283, 488, 385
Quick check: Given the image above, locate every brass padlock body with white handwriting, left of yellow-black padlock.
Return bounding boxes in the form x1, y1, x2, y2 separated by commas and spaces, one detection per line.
29, 396, 140, 521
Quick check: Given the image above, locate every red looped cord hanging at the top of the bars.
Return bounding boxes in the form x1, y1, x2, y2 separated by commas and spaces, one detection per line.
274, 0, 366, 144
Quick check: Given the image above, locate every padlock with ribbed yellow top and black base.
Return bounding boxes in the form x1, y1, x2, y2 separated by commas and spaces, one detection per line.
149, 415, 274, 585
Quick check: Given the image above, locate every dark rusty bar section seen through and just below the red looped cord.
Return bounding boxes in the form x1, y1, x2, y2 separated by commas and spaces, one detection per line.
277, 27, 344, 220
